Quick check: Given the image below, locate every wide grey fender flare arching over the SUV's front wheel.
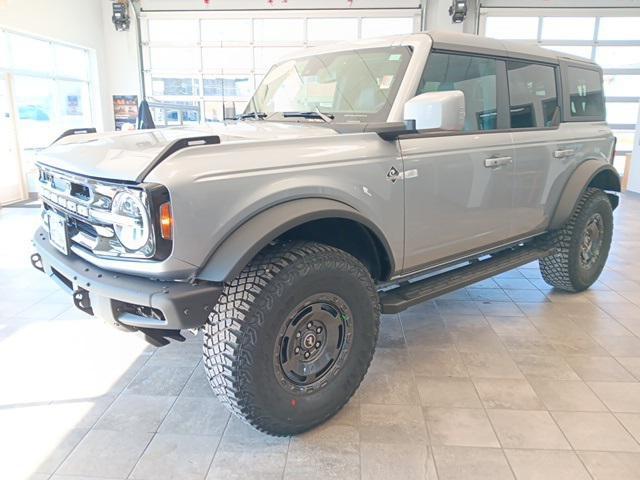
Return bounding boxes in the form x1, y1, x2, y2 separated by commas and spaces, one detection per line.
196, 198, 395, 282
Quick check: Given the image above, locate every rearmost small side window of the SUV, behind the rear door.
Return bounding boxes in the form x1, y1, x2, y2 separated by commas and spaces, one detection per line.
567, 67, 605, 120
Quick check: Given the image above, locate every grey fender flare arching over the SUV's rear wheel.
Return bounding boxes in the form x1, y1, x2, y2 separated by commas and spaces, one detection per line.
549, 160, 620, 230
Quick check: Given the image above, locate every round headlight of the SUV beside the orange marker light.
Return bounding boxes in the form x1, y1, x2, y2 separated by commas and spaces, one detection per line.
111, 191, 151, 250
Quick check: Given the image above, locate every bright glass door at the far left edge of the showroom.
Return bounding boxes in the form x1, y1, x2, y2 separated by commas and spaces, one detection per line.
0, 75, 25, 206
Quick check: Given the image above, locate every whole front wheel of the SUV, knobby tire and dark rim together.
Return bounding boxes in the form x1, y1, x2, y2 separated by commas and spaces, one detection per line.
204, 242, 380, 435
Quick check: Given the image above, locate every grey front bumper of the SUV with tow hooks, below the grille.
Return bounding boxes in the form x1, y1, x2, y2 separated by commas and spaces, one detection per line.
33, 228, 222, 331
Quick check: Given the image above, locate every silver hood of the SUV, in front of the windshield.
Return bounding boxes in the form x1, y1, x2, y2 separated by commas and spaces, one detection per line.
38, 120, 337, 181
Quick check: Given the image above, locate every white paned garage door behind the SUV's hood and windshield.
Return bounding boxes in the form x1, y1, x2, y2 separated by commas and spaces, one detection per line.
142, 8, 420, 125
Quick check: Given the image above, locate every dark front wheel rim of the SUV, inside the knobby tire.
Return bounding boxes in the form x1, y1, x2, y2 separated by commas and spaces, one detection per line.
274, 294, 353, 393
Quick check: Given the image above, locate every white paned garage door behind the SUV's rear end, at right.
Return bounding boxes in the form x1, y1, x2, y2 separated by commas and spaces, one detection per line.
480, 8, 640, 170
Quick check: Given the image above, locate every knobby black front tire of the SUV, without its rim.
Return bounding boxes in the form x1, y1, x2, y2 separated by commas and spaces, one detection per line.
204, 241, 380, 436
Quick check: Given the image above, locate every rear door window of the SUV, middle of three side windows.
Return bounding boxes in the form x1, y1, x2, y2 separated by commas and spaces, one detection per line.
507, 60, 559, 128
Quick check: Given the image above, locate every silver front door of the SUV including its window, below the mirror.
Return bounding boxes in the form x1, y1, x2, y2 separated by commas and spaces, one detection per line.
400, 52, 514, 272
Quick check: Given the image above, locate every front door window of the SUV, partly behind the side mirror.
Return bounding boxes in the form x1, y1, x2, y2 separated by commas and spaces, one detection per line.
418, 52, 498, 131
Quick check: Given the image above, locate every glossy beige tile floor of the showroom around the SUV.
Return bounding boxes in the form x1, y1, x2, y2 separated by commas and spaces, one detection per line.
0, 195, 640, 480
